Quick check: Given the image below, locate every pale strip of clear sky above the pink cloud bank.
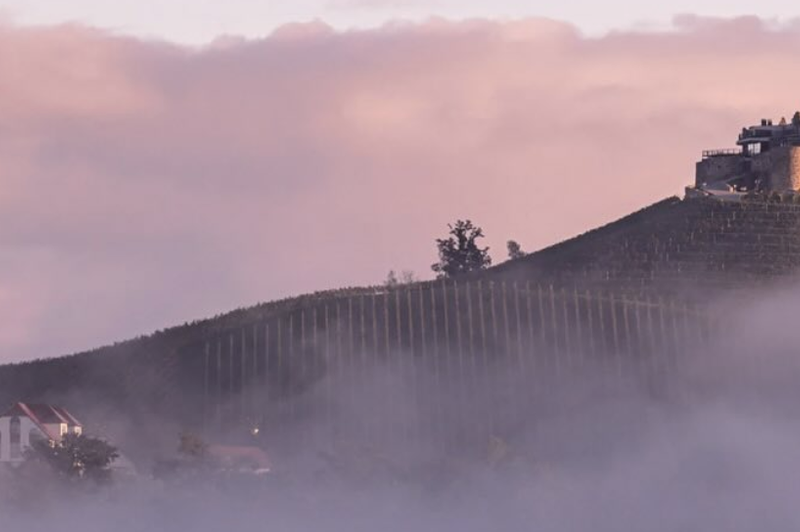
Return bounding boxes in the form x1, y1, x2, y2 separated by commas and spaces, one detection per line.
0, 0, 800, 45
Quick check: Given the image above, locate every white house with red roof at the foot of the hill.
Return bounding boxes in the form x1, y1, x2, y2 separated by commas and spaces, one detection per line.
0, 403, 83, 462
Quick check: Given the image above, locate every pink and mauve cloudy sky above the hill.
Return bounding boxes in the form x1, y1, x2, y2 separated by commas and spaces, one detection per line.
0, 0, 800, 361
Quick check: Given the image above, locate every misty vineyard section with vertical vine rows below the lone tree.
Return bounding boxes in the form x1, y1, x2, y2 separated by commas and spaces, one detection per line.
178, 281, 712, 446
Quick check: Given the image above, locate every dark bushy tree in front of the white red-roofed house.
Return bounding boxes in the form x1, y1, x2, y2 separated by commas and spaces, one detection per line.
26, 434, 119, 481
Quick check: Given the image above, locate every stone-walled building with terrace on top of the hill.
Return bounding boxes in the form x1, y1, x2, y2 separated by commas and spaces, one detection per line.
686, 112, 800, 199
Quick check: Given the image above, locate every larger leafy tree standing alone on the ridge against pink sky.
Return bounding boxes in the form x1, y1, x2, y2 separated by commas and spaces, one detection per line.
431, 220, 492, 279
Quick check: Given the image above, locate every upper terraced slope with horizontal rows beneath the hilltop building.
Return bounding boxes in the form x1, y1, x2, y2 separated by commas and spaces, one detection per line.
491, 198, 800, 299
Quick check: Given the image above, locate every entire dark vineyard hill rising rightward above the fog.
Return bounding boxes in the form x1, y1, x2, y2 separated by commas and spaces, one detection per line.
0, 198, 800, 447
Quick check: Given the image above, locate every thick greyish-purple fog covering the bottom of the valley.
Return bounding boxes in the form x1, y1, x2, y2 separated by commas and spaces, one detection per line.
0, 288, 800, 532
